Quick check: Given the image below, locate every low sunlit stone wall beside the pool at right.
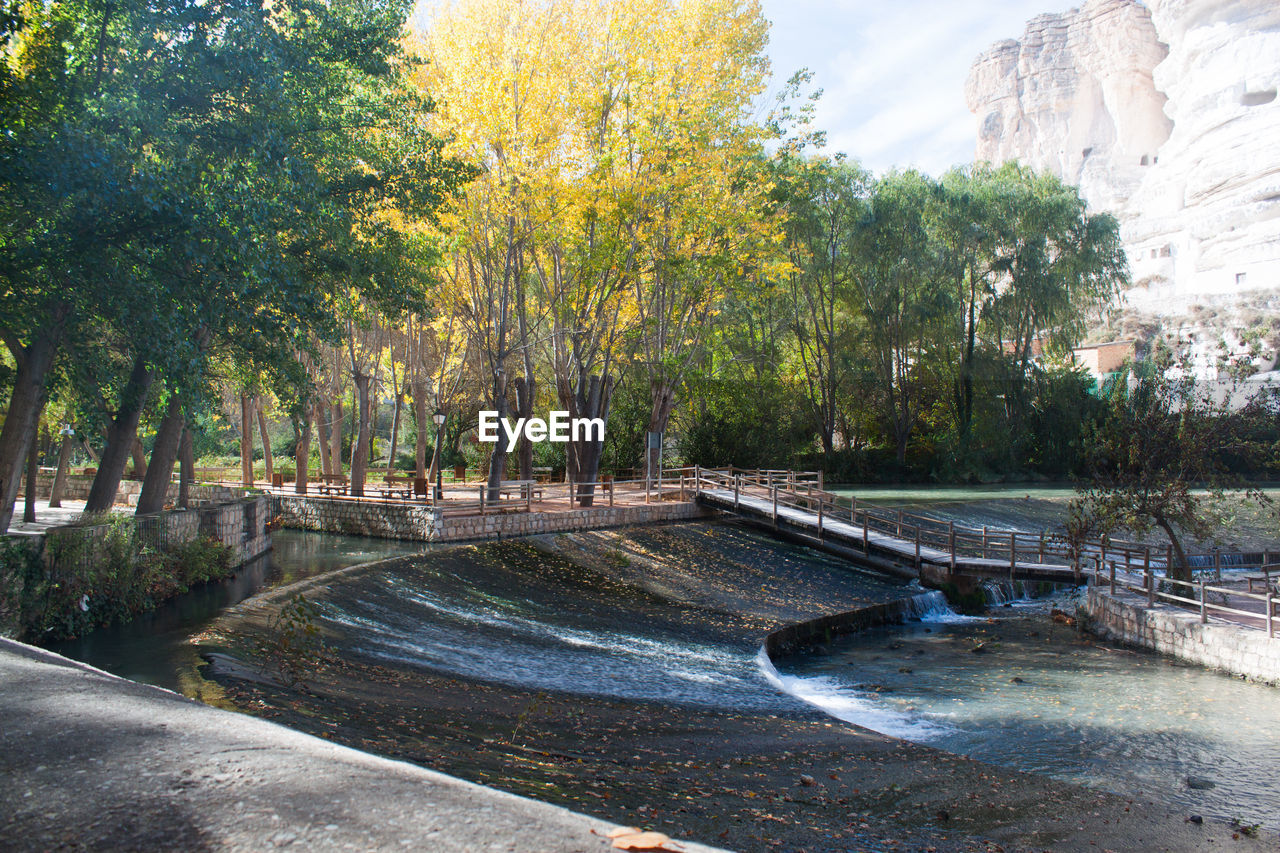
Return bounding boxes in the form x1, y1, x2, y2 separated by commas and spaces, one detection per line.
1084, 587, 1280, 684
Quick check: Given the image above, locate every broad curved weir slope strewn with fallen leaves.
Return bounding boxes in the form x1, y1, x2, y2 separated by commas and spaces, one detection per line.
194, 525, 1265, 850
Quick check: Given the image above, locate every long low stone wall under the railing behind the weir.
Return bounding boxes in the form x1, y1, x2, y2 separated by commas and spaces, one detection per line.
270, 494, 712, 542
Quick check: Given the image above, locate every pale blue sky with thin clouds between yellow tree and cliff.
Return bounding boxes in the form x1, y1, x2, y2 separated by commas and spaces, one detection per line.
762, 0, 1079, 175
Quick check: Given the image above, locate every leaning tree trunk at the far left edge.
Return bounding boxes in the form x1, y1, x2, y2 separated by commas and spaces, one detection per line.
0, 319, 64, 533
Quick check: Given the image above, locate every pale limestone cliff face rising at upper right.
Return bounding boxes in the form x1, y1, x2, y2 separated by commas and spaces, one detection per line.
965, 0, 1280, 313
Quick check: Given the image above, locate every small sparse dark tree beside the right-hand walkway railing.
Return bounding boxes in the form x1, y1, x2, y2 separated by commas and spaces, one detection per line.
1069, 365, 1280, 581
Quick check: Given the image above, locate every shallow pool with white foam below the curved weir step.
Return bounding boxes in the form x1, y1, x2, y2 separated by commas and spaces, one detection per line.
778, 613, 1280, 826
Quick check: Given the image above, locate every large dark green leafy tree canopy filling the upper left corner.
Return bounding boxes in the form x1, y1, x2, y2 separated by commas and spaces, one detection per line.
0, 0, 463, 526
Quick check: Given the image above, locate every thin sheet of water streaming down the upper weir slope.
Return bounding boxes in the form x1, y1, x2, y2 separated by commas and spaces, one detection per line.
207, 524, 919, 711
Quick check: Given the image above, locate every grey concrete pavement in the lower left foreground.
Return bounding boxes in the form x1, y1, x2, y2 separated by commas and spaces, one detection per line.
0, 639, 709, 852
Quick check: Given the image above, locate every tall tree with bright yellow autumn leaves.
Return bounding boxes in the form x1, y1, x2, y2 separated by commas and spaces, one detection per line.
419, 0, 776, 502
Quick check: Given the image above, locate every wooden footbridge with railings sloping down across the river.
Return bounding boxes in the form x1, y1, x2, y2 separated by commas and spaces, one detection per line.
680, 467, 1270, 585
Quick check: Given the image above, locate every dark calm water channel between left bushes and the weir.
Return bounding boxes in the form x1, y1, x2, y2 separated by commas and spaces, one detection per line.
49, 530, 426, 692
